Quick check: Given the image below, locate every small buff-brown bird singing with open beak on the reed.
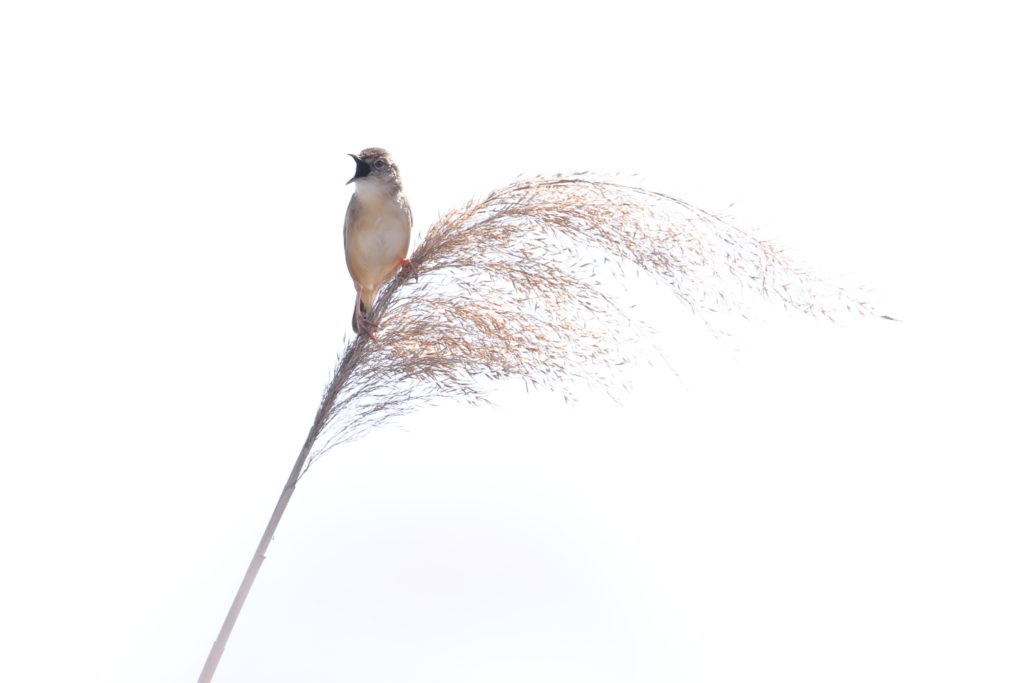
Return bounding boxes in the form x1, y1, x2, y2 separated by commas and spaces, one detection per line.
345, 147, 413, 338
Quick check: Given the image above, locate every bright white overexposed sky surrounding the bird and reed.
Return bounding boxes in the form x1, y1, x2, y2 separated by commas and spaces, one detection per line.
0, 0, 1024, 683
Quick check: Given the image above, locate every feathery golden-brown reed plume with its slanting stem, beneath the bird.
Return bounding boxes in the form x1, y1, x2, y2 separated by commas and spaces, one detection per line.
200, 174, 885, 683
